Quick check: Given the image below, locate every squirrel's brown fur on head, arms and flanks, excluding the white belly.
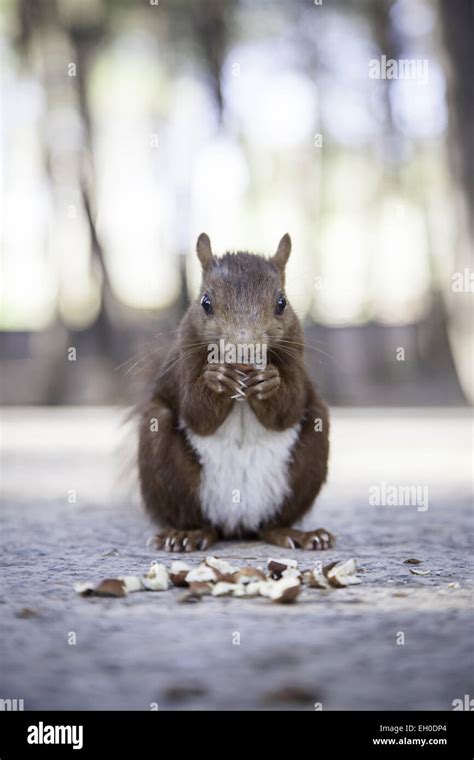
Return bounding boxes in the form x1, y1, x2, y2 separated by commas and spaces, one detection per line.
138, 235, 332, 551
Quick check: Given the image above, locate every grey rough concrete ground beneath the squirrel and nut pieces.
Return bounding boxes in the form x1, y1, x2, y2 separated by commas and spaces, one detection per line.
0, 408, 474, 710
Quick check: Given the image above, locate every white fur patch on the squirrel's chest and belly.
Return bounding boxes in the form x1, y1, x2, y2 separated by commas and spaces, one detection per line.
185, 402, 300, 535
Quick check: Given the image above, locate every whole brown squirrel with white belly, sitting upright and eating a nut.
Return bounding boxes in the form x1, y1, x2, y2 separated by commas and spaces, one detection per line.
138, 233, 334, 552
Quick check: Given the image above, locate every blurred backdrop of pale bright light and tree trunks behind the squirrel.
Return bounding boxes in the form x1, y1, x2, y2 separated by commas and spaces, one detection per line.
0, 0, 474, 406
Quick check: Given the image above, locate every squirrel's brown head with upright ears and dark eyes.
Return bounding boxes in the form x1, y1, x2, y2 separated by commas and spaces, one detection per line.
192, 233, 299, 348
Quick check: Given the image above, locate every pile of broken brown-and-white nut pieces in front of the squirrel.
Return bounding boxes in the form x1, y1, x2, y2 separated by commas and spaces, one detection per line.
74, 557, 361, 604
